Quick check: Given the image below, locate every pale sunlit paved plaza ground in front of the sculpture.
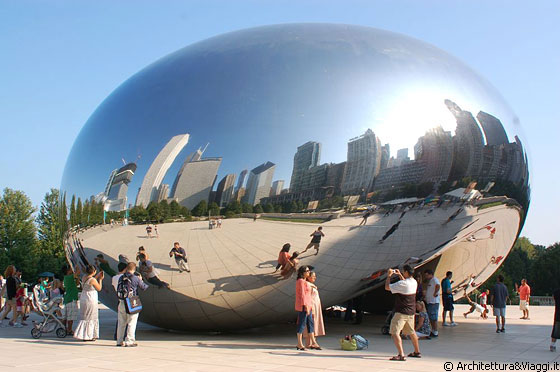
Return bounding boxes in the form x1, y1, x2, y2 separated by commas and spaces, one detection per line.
0, 305, 560, 372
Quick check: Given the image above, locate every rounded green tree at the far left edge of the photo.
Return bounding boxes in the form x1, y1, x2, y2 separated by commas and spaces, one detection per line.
0, 188, 38, 279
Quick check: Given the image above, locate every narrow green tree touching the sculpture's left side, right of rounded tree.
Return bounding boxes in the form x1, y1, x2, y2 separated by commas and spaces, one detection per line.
36, 189, 65, 272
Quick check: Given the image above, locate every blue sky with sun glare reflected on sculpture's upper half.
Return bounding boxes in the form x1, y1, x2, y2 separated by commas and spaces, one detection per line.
63, 24, 528, 203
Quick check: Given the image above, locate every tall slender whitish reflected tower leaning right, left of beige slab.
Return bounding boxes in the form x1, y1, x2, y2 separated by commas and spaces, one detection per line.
136, 134, 189, 207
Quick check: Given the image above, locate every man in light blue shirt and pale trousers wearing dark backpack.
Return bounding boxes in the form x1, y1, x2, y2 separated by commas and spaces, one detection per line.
117, 262, 148, 347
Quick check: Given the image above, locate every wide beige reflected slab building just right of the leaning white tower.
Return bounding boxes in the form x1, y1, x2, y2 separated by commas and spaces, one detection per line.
171, 149, 222, 209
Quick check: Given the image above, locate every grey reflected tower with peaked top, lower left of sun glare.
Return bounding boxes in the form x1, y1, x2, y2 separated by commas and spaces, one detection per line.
342, 129, 381, 195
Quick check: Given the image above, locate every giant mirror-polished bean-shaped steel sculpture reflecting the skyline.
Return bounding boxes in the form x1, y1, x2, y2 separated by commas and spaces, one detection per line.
61, 24, 530, 330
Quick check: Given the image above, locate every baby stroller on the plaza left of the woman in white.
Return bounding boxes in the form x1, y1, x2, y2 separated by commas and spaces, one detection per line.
31, 286, 66, 338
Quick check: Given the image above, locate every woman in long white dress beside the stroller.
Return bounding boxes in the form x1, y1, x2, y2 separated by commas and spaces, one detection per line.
74, 265, 103, 341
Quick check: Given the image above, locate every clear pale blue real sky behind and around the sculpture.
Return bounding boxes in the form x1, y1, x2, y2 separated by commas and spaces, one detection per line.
0, 0, 560, 244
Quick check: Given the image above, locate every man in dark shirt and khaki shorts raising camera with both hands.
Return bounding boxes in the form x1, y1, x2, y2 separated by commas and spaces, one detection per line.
385, 265, 422, 361
